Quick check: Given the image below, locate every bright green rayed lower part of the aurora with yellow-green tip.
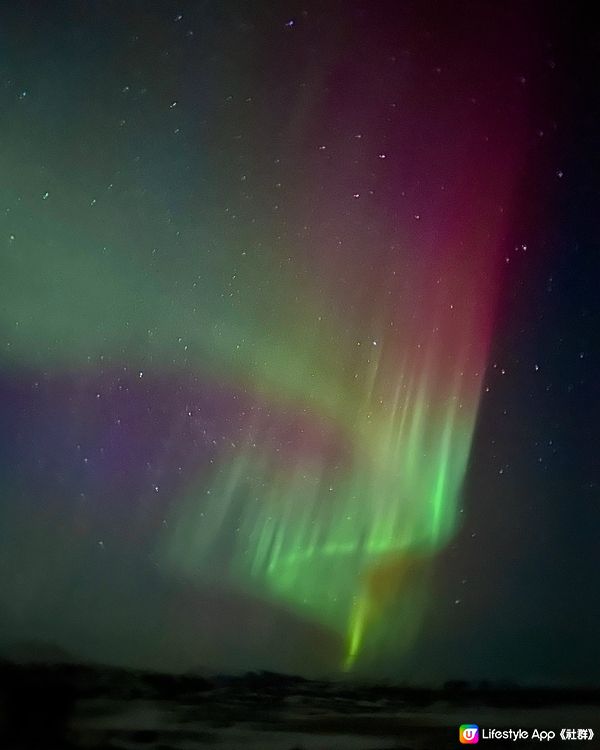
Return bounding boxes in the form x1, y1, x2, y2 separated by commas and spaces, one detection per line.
164, 318, 488, 666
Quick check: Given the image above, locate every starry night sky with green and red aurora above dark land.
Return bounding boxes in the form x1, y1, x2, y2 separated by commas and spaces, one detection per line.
0, 0, 600, 684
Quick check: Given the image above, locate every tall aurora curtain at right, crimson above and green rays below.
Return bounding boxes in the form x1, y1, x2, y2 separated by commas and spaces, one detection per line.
159, 8, 519, 669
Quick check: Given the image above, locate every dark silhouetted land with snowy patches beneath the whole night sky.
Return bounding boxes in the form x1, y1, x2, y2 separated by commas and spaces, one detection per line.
0, 662, 600, 750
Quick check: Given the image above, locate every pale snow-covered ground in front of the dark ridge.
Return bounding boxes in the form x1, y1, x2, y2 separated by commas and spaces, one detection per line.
73, 695, 599, 750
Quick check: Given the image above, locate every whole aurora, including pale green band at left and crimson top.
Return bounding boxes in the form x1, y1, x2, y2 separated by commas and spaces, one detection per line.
0, 3, 527, 669
